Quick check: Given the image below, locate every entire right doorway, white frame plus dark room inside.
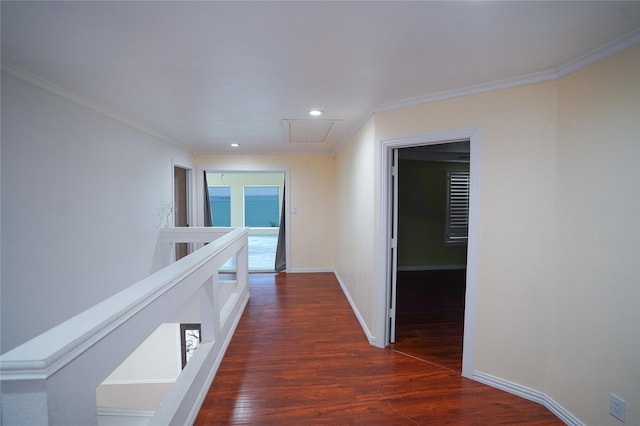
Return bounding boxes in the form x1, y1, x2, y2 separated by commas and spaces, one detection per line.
376, 129, 481, 377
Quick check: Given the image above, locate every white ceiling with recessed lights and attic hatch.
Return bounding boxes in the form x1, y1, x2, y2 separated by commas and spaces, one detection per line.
1, 1, 640, 154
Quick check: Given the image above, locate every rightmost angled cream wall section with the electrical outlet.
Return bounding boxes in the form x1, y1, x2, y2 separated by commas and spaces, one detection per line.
545, 46, 640, 425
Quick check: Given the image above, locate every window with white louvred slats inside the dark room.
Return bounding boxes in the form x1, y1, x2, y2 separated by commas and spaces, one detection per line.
446, 170, 470, 244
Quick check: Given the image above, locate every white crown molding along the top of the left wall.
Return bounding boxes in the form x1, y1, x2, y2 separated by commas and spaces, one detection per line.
2, 61, 193, 154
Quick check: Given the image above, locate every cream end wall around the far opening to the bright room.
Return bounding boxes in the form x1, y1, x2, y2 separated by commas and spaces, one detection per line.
196, 154, 337, 272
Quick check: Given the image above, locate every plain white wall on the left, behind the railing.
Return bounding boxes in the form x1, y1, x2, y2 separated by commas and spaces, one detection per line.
1, 73, 193, 352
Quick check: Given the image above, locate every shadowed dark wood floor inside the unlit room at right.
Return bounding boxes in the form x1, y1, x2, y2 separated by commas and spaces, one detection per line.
393, 269, 466, 373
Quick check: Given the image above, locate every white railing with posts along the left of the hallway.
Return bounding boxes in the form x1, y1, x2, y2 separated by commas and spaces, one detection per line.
0, 228, 249, 426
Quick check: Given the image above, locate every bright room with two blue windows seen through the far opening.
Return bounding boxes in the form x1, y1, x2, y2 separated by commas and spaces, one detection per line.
206, 170, 286, 272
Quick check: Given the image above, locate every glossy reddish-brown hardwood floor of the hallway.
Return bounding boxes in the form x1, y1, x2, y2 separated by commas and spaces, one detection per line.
195, 273, 562, 425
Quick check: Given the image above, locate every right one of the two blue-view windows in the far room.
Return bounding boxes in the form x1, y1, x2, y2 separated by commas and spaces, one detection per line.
244, 186, 280, 228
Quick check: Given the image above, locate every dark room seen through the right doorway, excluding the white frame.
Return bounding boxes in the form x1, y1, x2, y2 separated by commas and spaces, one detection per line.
393, 140, 470, 373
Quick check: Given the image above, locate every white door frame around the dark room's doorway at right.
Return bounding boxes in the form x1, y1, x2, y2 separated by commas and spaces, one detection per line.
376, 128, 481, 378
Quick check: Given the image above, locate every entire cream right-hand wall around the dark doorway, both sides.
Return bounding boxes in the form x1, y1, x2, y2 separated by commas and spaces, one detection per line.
337, 47, 640, 425
